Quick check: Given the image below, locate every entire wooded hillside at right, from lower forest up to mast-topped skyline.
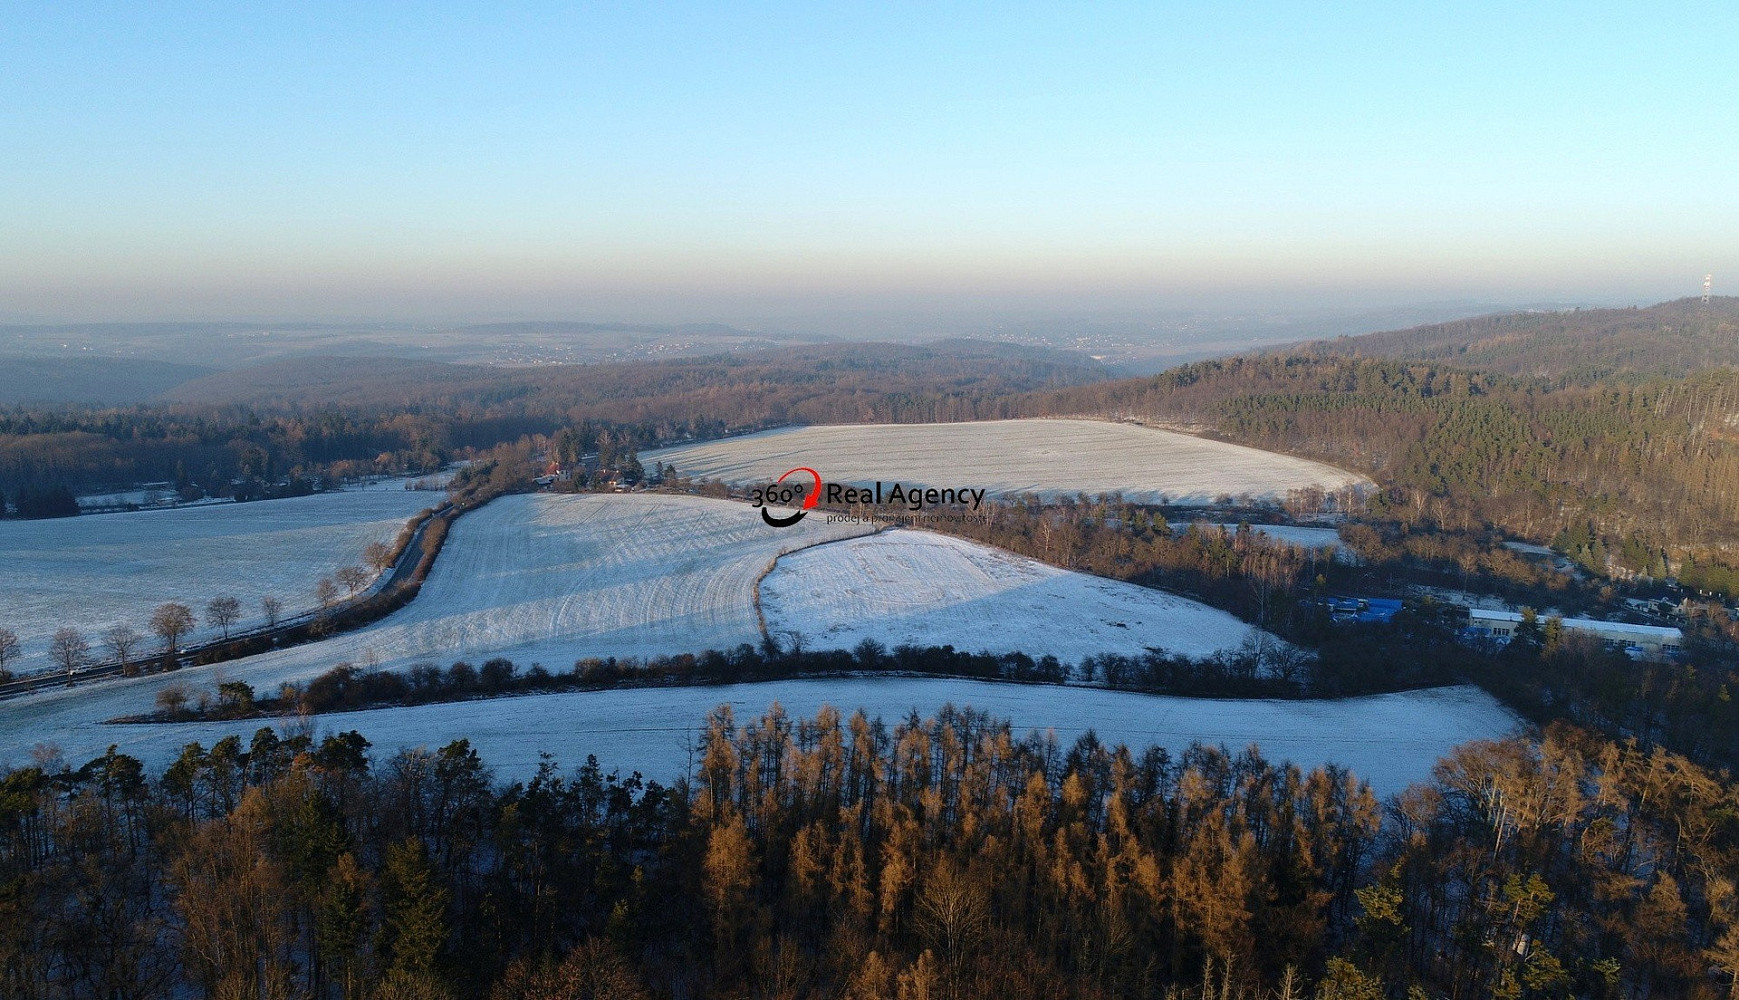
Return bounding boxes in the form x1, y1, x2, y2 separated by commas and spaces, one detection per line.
1007, 297, 1739, 556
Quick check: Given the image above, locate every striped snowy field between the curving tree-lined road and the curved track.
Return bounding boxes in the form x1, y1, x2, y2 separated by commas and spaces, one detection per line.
0, 490, 868, 763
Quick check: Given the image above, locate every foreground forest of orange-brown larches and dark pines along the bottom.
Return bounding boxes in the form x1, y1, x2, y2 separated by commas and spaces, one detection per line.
0, 706, 1739, 1000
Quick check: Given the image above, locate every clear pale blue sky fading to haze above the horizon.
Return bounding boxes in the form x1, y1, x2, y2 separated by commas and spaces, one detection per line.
0, 0, 1739, 322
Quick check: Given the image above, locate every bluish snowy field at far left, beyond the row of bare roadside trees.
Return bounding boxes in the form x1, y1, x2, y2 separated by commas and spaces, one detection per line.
0, 482, 440, 673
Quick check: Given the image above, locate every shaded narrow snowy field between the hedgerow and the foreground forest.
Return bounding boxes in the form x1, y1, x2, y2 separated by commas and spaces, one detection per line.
30, 678, 1520, 795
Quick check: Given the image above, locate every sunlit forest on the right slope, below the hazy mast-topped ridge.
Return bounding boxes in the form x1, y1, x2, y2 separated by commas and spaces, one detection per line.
1023, 355, 1739, 576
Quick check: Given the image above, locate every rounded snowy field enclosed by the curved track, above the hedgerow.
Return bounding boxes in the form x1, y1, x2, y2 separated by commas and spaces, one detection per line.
762, 530, 1278, 663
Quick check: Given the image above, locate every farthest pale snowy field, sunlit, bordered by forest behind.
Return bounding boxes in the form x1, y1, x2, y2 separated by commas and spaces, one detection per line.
640, 419, 1369, 504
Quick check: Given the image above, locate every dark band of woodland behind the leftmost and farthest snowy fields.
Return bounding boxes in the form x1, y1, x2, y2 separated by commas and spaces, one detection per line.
0, 343, 1104, 496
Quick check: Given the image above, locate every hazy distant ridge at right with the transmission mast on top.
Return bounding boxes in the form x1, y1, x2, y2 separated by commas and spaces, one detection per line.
1303, 296, 1739, 384
